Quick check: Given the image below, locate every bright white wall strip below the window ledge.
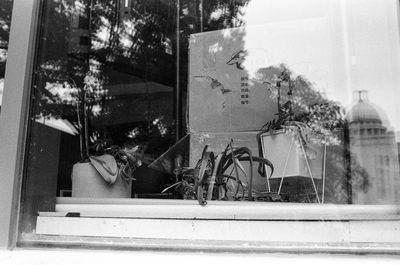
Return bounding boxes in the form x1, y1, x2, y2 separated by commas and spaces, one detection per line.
0, 250, 399, 265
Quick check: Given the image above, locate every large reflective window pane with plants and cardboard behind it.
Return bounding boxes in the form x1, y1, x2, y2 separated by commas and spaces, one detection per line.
22, 0, 400, 235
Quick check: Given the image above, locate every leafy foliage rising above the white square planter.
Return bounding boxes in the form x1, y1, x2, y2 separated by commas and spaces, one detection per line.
262, 65, 344, 143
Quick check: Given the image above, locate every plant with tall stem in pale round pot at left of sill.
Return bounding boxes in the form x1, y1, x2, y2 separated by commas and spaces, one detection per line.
72, 69, 141, 197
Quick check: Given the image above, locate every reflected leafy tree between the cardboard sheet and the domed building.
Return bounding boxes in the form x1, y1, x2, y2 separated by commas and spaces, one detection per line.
256, 65, 369, 203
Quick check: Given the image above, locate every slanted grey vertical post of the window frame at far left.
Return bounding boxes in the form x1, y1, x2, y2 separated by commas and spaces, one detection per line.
0, 0, 41, 248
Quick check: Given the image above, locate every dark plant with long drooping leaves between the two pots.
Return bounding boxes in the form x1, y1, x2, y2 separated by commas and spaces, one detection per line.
163, 141, 281, 206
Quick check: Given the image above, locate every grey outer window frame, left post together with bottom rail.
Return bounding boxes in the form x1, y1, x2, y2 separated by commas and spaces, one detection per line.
0, 0, 400, 254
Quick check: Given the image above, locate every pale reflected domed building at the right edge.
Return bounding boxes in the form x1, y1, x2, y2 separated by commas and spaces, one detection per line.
346, 90, 400, 204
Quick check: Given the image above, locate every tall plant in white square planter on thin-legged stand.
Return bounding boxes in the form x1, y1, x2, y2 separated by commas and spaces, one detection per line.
260, 65, 334, 200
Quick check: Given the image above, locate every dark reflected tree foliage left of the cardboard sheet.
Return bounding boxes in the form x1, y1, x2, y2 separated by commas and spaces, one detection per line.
28, 0, 247, 201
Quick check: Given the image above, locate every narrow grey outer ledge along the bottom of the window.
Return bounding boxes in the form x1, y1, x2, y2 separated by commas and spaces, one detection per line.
19, 234, 400, 255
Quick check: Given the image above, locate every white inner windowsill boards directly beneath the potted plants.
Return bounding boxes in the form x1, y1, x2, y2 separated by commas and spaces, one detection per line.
27, 198, 400, 248
